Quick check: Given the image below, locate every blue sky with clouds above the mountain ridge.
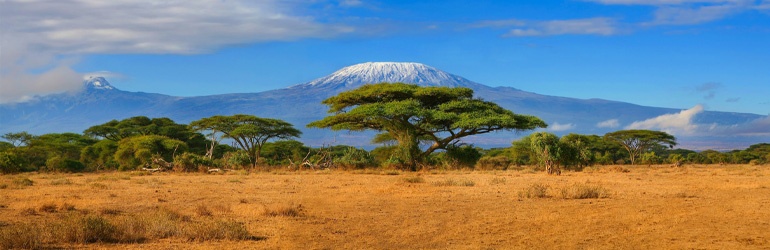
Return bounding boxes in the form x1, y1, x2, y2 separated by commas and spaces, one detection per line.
0, 0, 770, 115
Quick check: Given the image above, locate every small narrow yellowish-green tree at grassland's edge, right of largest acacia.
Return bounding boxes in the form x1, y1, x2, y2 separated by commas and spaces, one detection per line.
530, 132, 562, 175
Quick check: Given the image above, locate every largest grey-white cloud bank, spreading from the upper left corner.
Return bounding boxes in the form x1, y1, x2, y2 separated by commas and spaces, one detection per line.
0, 0, 355, 102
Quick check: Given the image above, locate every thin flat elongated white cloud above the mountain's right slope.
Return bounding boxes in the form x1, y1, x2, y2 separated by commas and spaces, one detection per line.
505, 17, 619, 36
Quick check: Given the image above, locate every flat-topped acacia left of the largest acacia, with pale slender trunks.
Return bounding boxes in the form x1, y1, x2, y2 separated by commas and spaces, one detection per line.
190, 114, 302, 167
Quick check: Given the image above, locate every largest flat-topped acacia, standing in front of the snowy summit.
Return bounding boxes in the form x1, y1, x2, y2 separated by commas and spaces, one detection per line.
307, 83, 547, 170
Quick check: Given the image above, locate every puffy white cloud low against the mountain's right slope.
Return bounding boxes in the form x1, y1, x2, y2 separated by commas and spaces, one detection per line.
626, 105, 703, 135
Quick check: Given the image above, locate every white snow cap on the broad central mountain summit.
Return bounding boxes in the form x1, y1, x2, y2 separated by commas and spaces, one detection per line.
292, 62, 480, 89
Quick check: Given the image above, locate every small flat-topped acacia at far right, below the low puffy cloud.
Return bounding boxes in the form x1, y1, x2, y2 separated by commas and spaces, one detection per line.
604, 130, 676, 165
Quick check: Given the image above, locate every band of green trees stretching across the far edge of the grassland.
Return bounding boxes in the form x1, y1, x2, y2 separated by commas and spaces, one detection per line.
0, 83, 770, 174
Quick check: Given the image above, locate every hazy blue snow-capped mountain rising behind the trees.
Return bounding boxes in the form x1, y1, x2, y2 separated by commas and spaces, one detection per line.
0, 62, 770, 148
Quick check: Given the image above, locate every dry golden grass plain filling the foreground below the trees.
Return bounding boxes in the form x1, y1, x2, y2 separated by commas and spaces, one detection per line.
0, 165, 770, 249
